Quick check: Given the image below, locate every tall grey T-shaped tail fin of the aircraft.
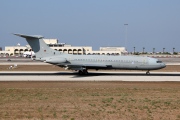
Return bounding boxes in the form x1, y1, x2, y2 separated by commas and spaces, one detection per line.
14, 34, 62, 59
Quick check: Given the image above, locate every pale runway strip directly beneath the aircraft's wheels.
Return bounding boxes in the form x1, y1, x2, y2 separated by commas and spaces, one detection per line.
0, 71, 180, 82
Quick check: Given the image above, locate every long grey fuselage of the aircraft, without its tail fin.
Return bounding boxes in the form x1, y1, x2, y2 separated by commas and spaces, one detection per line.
42, 55, 166, 70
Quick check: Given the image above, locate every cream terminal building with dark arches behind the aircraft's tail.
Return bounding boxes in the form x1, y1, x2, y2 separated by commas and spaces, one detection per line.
0, 39, 127, 56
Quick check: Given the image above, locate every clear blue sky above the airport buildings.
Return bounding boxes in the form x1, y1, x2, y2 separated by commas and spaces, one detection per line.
0, 0, 180, 52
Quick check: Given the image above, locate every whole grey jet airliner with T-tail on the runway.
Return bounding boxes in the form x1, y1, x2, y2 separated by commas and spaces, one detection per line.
14, 34, 166, 75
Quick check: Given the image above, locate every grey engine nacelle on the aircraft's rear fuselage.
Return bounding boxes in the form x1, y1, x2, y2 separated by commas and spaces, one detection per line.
45, 57, 67, 64
